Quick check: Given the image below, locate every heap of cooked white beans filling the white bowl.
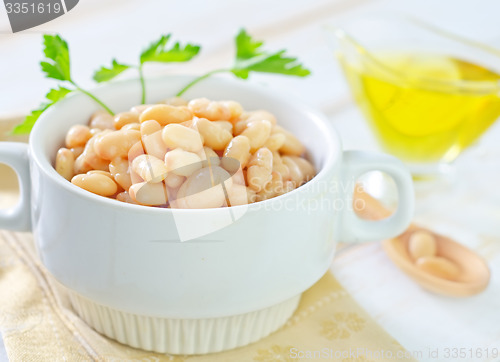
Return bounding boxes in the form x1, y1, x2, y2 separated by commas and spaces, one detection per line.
55, 98, 315, 209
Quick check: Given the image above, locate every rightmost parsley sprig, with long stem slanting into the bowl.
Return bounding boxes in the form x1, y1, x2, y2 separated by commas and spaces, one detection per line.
177, 29, 311, 97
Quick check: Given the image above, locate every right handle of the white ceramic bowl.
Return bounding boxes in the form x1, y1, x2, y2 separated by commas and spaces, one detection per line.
337, 151, 415, 242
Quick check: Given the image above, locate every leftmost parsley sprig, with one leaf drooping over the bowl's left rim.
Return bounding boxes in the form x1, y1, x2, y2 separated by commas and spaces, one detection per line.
12, 35, 113, 134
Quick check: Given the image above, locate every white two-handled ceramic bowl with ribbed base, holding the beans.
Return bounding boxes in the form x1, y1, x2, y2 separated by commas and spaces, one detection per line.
0, 77, 413, 353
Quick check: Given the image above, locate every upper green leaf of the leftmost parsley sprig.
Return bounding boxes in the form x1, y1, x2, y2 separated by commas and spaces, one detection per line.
40, 35, 71, 81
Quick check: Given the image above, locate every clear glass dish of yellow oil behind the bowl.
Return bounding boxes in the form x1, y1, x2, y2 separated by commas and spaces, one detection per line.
328, 17, 500, 179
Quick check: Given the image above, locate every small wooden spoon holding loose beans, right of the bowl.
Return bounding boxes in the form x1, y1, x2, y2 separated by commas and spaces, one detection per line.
354, 187, 490, 297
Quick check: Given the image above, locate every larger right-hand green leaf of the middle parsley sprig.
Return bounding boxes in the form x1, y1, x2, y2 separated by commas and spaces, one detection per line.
140, 34, 200, 64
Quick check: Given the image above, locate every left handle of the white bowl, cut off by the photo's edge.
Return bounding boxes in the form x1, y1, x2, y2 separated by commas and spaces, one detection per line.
0, 142, 31, 231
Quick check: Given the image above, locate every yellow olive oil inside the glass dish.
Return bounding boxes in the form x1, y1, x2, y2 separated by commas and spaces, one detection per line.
340, 53, 500, 163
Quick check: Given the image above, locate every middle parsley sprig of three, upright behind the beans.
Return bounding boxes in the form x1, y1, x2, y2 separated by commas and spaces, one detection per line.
94, 34, 200, 104
